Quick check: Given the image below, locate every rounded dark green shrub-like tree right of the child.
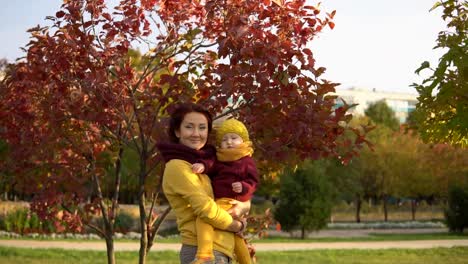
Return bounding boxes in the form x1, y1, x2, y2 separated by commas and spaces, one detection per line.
274, 161, 333, 239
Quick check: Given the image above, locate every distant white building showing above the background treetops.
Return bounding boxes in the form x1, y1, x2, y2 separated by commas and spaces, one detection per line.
336, 87, 418, 123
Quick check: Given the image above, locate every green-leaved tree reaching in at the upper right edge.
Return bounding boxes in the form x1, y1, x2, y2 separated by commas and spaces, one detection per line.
413, 0, 468, 147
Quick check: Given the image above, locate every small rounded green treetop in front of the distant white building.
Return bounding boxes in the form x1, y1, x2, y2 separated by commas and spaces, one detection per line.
364, 100, 400, 131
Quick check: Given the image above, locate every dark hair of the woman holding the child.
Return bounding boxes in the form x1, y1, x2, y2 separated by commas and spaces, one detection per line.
168, 103, 213, 143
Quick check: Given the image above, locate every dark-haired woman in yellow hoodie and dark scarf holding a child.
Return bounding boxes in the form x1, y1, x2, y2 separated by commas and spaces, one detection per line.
158, 104, 247, 264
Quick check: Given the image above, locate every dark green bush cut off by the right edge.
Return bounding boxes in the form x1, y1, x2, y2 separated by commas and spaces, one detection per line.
444, 186, 468, 233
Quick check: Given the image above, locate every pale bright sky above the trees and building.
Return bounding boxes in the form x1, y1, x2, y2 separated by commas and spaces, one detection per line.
0, 0, 446, 94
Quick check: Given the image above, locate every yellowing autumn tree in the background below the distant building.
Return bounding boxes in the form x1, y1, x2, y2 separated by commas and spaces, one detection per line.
333, 114, 427, 222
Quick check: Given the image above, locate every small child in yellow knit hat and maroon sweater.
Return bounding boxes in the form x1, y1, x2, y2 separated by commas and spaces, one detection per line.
192, 119, 258, 264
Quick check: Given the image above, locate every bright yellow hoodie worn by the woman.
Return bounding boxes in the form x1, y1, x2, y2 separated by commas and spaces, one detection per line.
163, 159, 234, 258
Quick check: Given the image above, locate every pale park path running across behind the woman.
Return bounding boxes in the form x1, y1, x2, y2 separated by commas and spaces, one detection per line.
0, 239, 468, 251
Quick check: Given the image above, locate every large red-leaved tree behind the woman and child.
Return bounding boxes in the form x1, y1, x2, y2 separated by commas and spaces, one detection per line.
0, 0, 366, 263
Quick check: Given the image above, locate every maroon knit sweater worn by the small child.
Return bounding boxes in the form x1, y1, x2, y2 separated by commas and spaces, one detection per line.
199, 156, 258, 202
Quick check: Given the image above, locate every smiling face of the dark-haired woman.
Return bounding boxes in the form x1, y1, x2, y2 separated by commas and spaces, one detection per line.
175, 112, 208, 150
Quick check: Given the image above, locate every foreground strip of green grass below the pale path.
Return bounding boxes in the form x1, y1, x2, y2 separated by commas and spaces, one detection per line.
0, 247, 468, 264
